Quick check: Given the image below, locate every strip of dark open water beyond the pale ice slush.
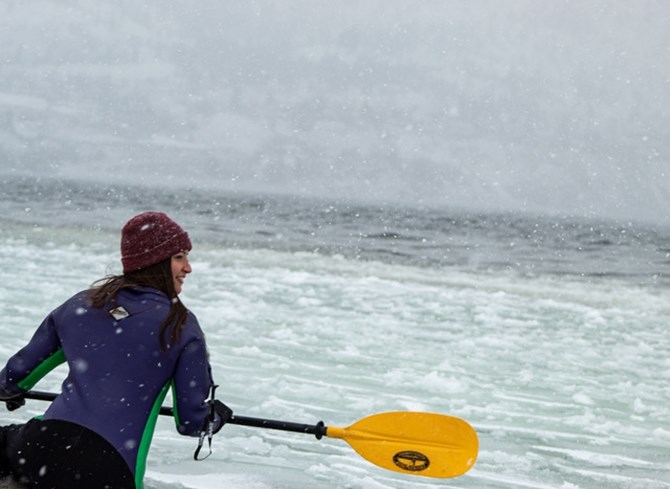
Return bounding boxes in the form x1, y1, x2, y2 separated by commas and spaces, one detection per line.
0, 176, 670, 286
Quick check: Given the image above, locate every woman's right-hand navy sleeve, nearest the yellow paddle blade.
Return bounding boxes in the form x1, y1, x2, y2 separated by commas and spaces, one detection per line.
172, 337, 221, 436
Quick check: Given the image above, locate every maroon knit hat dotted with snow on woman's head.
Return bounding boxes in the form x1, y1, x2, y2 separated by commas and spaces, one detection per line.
121, 212, 191, 273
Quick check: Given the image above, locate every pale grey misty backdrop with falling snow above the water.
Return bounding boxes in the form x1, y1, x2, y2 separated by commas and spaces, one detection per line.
0, 0, 670, 224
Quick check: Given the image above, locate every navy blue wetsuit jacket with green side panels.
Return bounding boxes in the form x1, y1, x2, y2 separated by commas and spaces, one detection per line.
0, 287, 220, 487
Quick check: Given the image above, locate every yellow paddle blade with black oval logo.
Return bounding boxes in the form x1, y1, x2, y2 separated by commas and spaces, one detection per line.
326, 412, 479, 478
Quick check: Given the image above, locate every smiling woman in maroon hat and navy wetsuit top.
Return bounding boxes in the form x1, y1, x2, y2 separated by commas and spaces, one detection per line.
0, 212, 232, 489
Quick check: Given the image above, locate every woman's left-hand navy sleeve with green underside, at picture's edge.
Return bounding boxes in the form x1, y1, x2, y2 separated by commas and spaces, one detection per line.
0, 313, 65, 400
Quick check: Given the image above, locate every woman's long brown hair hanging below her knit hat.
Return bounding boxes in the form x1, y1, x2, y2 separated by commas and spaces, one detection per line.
88, 258, 188, 350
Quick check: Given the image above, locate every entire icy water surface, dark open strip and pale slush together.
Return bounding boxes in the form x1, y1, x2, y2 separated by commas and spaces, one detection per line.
0, 180, 670, 489
